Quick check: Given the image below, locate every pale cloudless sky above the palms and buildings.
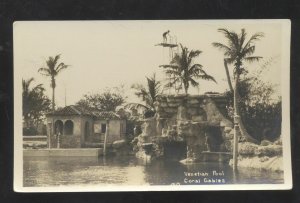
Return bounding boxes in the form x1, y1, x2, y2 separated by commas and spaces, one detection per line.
14, 20, 283, 106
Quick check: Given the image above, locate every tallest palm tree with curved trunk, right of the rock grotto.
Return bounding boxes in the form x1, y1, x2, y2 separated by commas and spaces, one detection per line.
213, 28, 264, 142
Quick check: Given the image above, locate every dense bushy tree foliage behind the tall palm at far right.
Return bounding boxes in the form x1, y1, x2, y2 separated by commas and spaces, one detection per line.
227, 70, 282, 141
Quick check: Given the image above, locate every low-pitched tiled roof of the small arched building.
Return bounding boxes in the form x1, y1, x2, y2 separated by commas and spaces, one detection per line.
47, 105, 120, 119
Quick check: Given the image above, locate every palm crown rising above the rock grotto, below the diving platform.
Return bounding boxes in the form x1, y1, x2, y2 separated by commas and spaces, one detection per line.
160, 44, 216, 94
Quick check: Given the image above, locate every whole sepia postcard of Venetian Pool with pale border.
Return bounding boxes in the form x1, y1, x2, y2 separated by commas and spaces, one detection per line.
13, 20, 292, 192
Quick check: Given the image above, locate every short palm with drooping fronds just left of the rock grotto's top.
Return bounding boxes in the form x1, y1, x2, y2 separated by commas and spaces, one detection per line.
125, 74, 162, 116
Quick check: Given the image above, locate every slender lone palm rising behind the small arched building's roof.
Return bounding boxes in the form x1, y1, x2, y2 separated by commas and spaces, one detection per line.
38, 54, 69, 111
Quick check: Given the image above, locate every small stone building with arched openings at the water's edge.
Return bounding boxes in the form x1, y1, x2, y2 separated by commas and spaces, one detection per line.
46, 105, 126, 148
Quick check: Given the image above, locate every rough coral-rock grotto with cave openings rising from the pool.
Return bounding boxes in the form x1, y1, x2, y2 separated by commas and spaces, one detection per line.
137, 94, 233, 160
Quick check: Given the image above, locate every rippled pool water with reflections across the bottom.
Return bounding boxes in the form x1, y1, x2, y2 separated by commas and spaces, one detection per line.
24, 156, 283, 187
